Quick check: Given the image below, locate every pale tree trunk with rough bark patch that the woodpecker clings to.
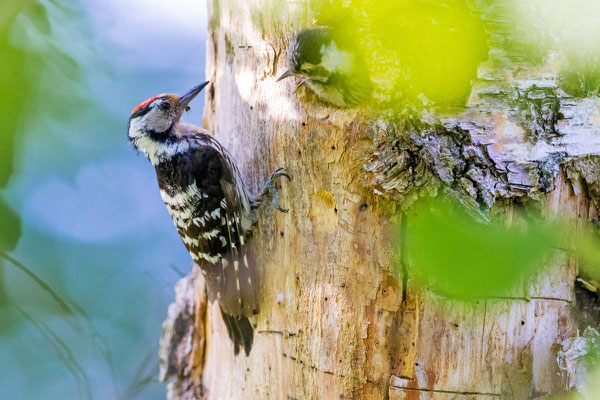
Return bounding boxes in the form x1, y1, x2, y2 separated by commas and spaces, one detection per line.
162, 0, 600, 400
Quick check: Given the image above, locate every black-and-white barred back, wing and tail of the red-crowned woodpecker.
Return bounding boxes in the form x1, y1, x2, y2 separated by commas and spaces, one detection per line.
159, 142, 258, 354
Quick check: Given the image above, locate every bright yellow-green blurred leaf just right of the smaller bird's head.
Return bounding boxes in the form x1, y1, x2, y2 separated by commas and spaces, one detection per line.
312, 0, 489, 110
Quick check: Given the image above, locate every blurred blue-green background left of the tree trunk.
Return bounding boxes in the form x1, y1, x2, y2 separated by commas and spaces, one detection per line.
0, 0, 206, 400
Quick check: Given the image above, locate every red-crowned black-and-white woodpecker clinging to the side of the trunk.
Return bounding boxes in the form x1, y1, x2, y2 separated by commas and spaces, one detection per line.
127, 82, 290, 355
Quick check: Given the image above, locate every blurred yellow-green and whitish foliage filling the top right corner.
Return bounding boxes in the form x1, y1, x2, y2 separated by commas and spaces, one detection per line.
310, 0, 600, 113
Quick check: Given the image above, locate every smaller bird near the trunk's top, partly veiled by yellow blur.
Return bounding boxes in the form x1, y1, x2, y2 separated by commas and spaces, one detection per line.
277, 27, 373, 108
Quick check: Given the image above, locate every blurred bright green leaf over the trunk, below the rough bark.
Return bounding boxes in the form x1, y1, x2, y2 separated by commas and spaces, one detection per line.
397, 197, 600, 400
